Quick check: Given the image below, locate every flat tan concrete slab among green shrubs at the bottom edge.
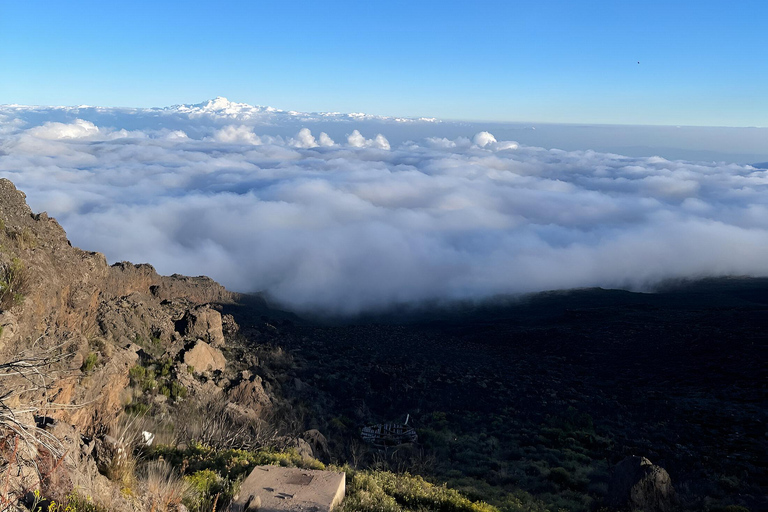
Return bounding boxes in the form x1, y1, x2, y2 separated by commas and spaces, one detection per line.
230, 466, 346, 512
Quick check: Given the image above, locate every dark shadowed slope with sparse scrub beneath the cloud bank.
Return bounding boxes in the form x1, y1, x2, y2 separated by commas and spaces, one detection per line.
220, 278, 768, 511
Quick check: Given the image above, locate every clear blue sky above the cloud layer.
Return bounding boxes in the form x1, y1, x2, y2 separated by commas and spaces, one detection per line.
0, 0, 768, 126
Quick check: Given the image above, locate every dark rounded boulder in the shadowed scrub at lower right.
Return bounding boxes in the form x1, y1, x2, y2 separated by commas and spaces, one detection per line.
606, 456, 675, 512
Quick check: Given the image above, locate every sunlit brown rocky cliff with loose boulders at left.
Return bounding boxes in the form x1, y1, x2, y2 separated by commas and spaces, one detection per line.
0, 179, 272, 509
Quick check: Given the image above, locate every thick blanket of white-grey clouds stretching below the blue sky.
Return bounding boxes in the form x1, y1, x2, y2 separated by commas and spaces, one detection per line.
0, 99, 768, 313
